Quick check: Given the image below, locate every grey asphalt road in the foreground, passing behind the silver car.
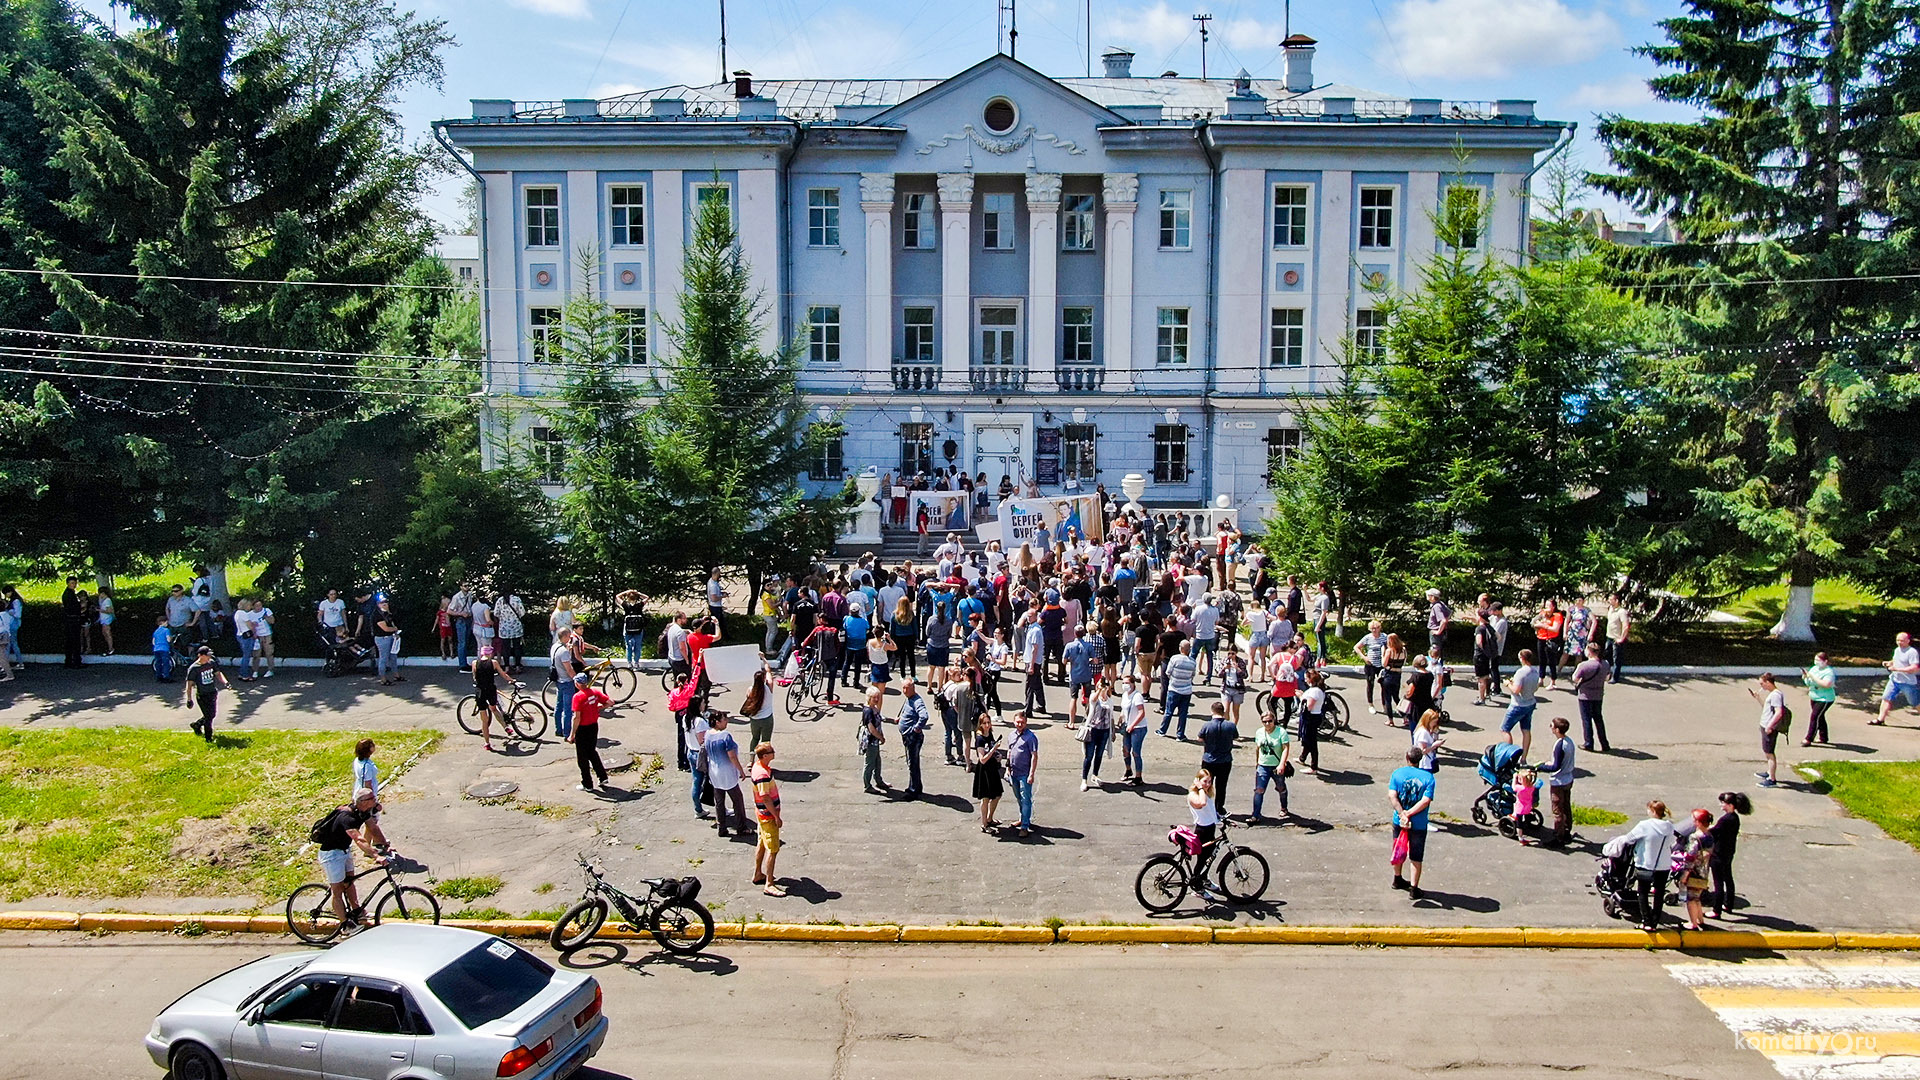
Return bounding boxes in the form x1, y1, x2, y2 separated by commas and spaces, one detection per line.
0, 934, 1789, 1080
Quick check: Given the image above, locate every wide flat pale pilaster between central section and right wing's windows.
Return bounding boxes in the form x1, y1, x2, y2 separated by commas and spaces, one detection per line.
1213, 169, 1269, 395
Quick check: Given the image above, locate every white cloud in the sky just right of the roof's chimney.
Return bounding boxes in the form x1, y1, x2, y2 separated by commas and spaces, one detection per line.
1392, 0, 1619, 79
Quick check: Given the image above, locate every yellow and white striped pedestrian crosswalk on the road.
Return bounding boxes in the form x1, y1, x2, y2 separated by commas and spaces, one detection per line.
1667, 957, 1920, 1080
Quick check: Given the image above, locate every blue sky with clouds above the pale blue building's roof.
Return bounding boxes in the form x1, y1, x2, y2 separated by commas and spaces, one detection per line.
86, 0, 1684, 221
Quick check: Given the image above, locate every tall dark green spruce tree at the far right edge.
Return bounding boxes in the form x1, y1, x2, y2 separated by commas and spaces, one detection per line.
1592, 0, 1920, 640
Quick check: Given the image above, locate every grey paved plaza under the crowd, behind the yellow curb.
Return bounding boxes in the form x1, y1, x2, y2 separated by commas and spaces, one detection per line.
0, 667, 1920, 930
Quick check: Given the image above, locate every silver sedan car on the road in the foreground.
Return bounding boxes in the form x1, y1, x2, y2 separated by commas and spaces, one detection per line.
146, 922, 607, 1080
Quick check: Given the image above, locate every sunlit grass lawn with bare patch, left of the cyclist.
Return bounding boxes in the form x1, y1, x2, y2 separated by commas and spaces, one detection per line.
0, 728, 442, 907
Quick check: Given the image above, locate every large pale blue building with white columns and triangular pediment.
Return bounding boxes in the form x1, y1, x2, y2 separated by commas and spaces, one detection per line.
436, 44, 1571, 513
